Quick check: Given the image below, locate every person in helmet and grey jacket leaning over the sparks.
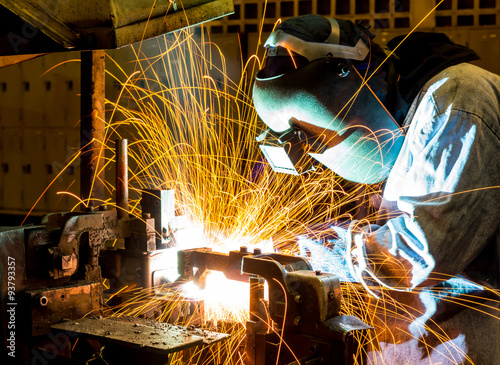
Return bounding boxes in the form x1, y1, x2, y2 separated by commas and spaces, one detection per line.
253, 15, 500, 364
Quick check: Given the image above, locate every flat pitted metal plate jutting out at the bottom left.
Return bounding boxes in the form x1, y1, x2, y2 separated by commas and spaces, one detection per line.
52, 316, 229, 365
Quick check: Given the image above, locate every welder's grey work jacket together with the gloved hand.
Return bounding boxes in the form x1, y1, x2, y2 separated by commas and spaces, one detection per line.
356, 63, 500, 365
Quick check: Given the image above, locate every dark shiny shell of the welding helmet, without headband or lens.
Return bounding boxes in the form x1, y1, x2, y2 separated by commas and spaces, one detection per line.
253, 19, 403, 184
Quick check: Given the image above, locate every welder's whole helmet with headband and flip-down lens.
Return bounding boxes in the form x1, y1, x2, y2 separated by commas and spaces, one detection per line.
253, 15, 403, 184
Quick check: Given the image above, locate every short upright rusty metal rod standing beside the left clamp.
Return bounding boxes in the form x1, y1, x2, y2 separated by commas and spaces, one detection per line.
115, 139, 129, 219
